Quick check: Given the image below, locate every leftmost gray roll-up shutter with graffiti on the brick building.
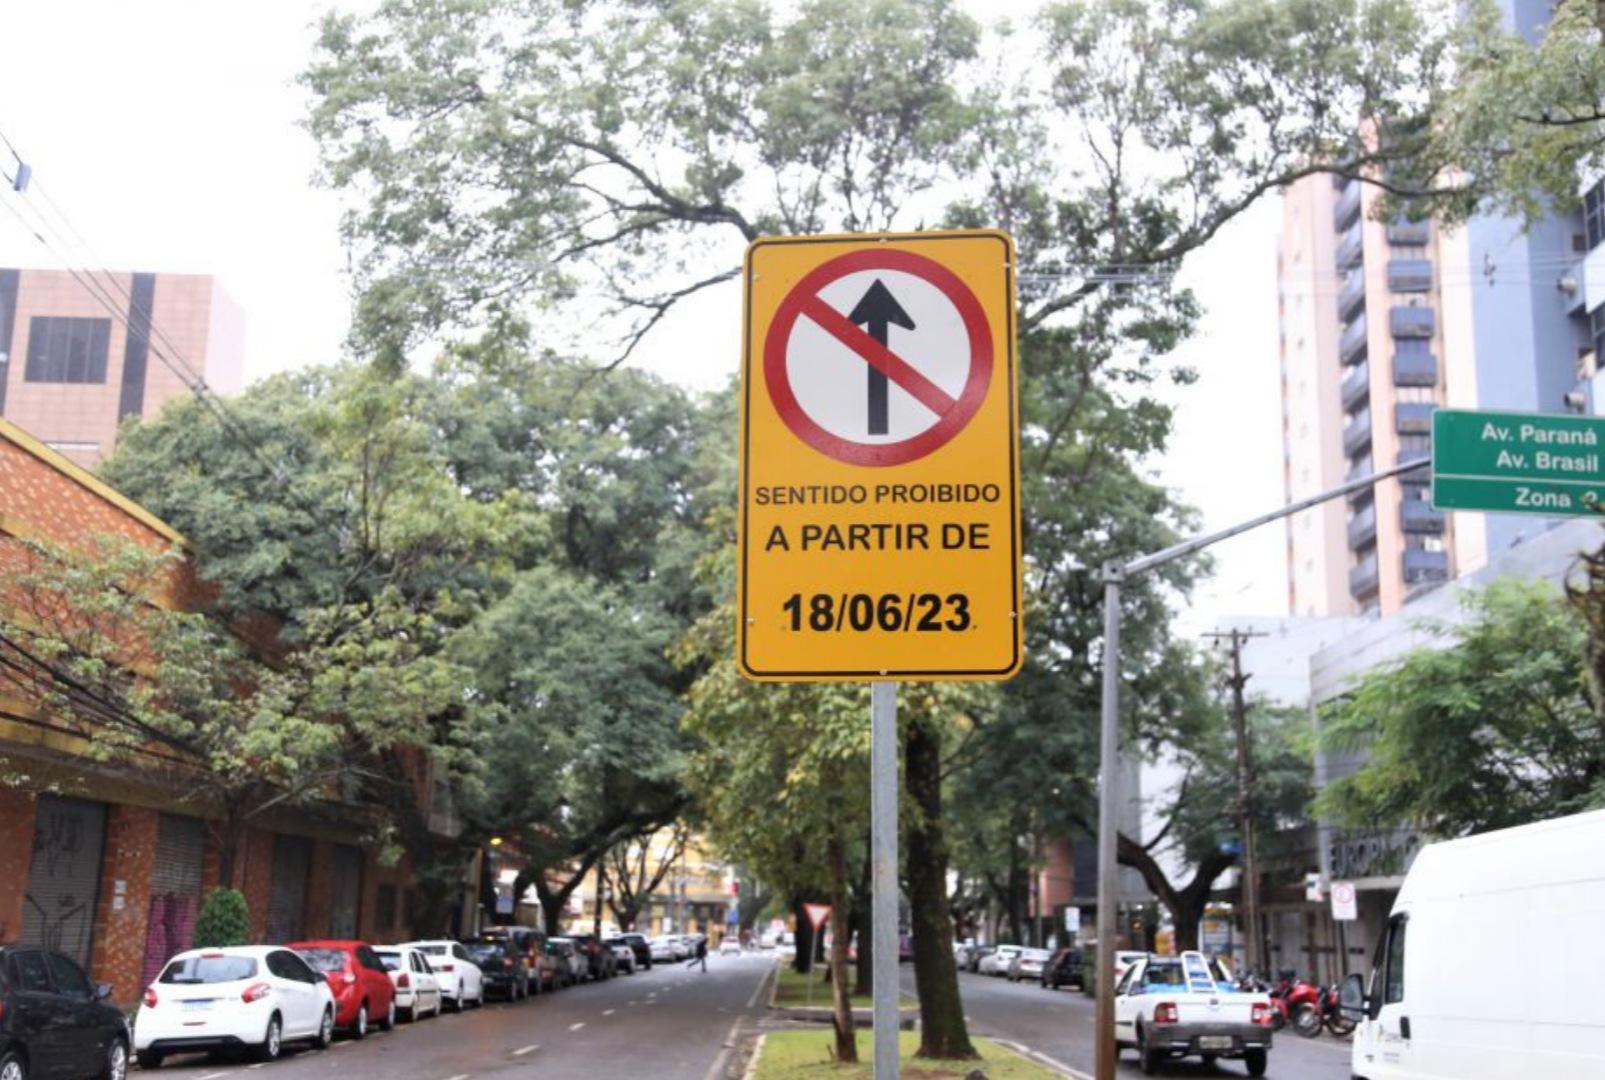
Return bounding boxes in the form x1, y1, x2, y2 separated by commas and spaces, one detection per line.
19, 794, 106, 971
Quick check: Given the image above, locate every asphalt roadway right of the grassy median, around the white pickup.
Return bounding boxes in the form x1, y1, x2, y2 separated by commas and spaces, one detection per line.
930, 968, 1350, 1080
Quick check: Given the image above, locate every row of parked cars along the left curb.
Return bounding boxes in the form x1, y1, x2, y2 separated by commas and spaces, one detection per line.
0, 926, 677, 1080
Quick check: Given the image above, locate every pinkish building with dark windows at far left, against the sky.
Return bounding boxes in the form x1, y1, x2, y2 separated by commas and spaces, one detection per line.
0, 270, 246, 467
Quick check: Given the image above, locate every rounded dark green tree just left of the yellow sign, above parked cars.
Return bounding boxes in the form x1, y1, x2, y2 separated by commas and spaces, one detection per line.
457, 566, 685, 934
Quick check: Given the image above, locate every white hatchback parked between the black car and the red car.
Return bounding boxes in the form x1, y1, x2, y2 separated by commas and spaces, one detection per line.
133, 945, 334, 1069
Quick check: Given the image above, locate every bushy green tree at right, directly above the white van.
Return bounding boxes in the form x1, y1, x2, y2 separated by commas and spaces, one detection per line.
1314, 579, 1605, 838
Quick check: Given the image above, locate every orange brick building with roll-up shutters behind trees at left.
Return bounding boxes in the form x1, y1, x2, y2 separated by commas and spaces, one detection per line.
0, 420, 459, 1003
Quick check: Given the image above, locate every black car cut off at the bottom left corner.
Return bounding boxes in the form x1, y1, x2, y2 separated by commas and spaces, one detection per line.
0, 945, 130, 1080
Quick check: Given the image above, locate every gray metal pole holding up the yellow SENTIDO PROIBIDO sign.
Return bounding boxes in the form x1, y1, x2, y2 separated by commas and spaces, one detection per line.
870, 682, 899, 1080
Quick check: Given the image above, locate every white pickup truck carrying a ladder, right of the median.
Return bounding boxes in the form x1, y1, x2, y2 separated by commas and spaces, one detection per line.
1114, 952, 1273, 1077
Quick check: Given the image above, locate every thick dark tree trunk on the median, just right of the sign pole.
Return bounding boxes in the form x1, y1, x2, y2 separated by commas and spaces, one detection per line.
905, 721, 976, 1059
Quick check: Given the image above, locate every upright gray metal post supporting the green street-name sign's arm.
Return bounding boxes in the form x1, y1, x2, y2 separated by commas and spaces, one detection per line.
1095, 563, 1125, 1080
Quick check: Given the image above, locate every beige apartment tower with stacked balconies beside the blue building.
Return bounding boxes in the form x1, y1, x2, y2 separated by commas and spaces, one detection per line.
1278, 177, 1457, 616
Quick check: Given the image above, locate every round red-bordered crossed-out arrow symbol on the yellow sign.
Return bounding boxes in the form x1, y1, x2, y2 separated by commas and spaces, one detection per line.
764, 249, 992, 465
